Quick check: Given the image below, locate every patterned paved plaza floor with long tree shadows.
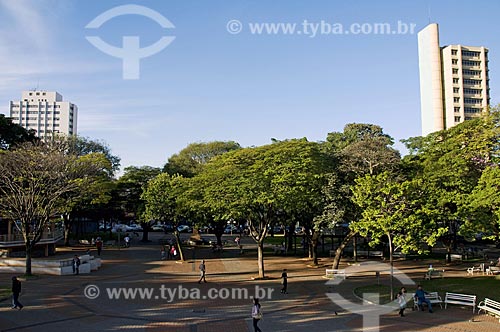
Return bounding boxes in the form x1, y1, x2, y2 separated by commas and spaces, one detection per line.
0, 234, 500, 332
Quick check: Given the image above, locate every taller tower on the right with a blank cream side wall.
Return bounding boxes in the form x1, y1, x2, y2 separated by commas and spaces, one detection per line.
418, 23, 490, 136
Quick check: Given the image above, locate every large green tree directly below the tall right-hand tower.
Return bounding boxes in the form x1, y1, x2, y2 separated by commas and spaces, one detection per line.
404, 110, 500, 261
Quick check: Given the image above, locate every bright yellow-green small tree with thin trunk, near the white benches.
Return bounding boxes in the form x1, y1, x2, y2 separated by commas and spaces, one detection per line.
349, 171, 446, 298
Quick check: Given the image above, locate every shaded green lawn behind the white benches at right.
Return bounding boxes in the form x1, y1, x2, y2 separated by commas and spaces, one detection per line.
354, 276, 500, 304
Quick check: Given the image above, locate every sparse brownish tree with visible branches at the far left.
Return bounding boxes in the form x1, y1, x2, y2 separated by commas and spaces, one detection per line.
0, 143, 108, 275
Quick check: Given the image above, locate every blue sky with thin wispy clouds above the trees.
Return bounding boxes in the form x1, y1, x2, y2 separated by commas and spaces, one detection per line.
0, 0, 500, 174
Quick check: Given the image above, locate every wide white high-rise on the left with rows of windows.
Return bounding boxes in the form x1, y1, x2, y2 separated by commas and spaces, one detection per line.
9, 90, 78, 139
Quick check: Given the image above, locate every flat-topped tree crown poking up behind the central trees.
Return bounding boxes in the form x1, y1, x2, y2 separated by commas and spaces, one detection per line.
163, 141, 241, 178
